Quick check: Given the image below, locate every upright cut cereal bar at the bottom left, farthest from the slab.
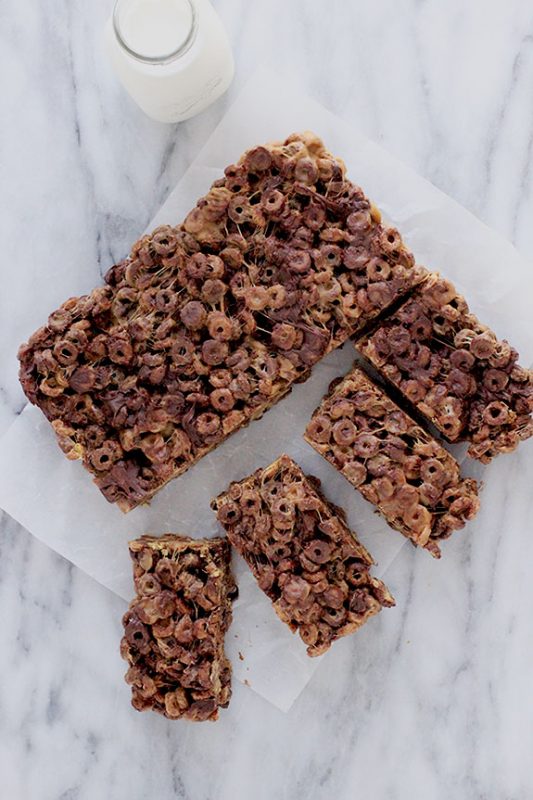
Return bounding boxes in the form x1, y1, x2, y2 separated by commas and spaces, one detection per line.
120, 534, 237, 721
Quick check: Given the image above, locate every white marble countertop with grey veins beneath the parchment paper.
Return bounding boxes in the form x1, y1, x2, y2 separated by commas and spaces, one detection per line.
0, 0, 533, 800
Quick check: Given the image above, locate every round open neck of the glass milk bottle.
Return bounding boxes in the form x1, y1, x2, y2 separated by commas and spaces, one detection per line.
113, 0, 199, 65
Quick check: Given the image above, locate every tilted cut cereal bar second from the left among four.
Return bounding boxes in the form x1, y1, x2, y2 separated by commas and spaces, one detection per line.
212, 455, 394, 656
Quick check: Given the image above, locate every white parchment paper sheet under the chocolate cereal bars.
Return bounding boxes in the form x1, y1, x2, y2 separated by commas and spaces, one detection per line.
0, 70, 533, 711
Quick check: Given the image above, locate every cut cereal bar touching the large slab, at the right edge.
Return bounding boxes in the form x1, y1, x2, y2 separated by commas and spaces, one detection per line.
356, 273, 533, 463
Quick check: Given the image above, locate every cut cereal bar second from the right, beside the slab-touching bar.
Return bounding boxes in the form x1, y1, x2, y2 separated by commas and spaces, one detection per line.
305, 368, 479, 558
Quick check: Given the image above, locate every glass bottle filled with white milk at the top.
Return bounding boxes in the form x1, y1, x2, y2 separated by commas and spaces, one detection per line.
105, 0, 234, 122
